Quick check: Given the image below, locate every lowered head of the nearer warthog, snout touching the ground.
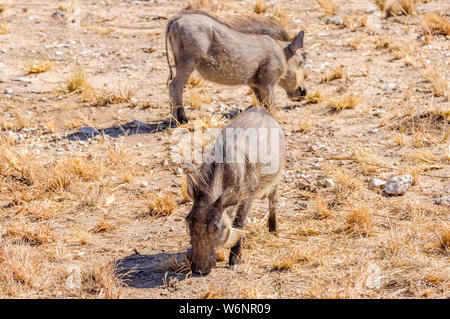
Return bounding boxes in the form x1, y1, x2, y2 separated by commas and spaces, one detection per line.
186, 175, 244, 275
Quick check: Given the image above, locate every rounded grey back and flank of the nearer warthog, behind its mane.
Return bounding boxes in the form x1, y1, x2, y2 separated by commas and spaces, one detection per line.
203, 107, 286, 197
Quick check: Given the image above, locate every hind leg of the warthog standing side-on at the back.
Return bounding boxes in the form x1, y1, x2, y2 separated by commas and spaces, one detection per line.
169, 62, 195, 123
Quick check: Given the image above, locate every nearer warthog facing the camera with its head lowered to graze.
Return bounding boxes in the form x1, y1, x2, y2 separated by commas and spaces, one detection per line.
186, 107, 285, 275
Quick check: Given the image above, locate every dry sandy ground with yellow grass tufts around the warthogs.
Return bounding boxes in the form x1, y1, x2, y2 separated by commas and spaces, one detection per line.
0, 0, 450, 298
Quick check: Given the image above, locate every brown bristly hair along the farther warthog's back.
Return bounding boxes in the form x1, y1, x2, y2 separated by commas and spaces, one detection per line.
181, 9, 292, 42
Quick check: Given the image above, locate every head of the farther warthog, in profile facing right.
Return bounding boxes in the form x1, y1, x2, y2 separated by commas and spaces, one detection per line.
279, 31, 306, 101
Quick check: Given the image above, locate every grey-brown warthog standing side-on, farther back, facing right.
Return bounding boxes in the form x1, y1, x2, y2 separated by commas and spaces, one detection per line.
165, 11, 306, 123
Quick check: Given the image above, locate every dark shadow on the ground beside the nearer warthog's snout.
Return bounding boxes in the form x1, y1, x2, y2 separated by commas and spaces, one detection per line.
115, 252, 190, 288
